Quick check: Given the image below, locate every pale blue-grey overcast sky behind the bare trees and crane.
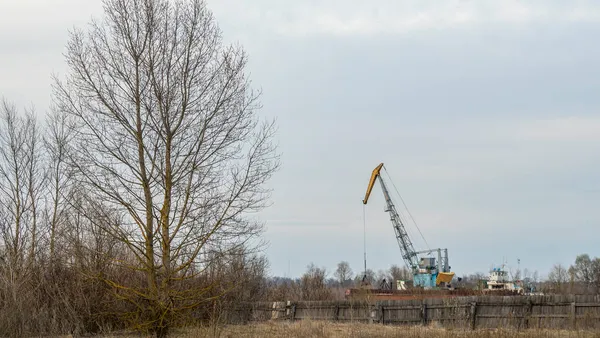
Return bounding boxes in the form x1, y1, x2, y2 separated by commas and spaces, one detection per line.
0, 0, 600, 276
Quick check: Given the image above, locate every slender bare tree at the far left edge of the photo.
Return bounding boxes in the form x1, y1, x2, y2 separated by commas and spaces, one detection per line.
0, 100, 44, 335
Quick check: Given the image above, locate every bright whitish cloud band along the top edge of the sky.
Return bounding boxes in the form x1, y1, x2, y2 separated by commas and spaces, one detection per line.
211, 0, 600, 37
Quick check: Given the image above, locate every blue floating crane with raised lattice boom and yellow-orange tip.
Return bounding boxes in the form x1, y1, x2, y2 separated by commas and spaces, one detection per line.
363, 163, 454, 289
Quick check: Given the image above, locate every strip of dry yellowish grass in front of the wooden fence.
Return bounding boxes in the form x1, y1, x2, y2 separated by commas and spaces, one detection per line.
91, 321, 600, 338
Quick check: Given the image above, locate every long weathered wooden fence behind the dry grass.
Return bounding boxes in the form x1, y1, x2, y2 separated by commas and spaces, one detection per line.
225, 295, 600, 330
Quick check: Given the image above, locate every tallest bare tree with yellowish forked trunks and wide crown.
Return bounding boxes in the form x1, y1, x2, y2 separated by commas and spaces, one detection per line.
54, 0, 278, 336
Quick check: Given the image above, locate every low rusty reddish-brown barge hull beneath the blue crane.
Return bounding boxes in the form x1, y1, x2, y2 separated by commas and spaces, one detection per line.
346, 289, 519, 300
